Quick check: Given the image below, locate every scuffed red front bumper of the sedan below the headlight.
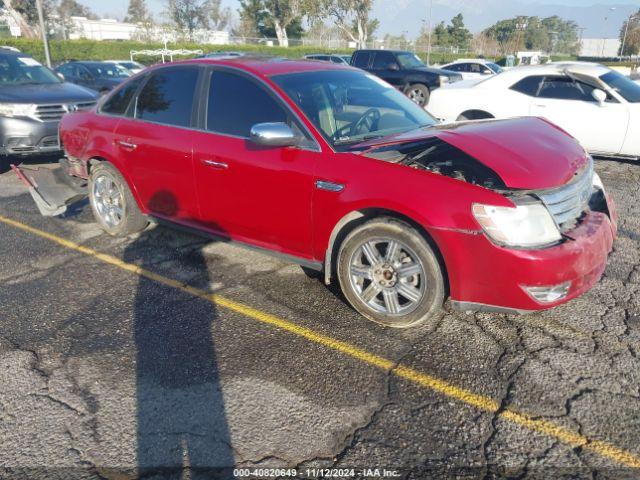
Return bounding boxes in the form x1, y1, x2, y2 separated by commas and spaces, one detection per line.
438, 200, 617, 313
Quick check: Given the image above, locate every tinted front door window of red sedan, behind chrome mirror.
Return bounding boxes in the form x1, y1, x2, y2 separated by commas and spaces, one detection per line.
206, 70, 288, 138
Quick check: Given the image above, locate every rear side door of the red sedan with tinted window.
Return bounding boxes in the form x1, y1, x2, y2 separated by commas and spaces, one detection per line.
114, 66, 201, 224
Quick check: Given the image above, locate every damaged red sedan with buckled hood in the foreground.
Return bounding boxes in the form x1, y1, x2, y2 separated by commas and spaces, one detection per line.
16, 58, 615, 327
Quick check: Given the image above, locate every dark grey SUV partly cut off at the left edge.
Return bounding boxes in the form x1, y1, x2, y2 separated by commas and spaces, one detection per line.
0, 48, 98, 156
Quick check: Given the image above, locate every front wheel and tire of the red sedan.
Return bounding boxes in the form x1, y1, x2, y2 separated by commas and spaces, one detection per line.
337, 217, 445, 328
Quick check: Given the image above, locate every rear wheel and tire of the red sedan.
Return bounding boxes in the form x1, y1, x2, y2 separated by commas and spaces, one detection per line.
89, 162, 149, 237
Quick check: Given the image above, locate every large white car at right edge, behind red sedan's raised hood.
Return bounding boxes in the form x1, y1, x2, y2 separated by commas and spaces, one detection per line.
428, 62, 640, 158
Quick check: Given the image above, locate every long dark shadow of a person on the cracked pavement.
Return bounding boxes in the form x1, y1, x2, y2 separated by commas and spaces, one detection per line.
124, 192, 234, 479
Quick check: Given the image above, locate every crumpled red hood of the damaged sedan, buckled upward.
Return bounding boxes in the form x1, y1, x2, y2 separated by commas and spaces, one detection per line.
358, 117, 589, 190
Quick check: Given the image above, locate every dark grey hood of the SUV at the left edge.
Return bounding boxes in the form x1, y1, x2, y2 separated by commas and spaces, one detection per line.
0, 82, 98, 104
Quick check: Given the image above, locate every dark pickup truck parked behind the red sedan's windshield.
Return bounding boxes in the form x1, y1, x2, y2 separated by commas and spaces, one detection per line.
351, 50, 462, 107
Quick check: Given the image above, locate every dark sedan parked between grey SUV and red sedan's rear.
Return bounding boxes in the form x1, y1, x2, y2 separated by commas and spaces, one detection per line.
56, 62, 132, 94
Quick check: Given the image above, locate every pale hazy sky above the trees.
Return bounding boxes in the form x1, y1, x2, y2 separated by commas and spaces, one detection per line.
79, 0, 640, 38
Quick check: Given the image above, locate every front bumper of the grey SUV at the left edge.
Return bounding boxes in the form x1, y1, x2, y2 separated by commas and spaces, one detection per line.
0, 117, 61, 156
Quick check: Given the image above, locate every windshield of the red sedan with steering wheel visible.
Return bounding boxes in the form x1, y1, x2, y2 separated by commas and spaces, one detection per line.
273, 70, 437, 147
